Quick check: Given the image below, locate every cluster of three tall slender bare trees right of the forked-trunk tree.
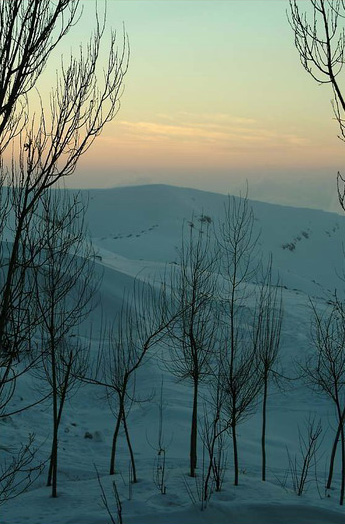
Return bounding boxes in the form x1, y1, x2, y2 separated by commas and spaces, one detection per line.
155, 196, 283, 500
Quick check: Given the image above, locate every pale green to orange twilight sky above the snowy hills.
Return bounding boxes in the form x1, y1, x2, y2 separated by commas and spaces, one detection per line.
41, 0, 345, 210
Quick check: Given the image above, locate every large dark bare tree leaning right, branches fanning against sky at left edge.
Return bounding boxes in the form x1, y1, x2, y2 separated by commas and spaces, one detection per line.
0, 0, 127, 360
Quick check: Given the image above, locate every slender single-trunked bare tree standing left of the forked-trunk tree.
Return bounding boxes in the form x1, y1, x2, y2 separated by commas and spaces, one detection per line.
35, 190, 97, 497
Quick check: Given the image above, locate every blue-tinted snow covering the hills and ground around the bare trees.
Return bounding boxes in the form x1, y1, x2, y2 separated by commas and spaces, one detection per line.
0, 185, 345, 524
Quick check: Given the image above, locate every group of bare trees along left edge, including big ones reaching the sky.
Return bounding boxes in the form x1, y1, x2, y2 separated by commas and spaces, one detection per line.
0, 0, 128, 503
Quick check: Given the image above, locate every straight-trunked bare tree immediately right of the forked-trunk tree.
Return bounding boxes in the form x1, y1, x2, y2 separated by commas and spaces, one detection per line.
164, 216, 217, 477
